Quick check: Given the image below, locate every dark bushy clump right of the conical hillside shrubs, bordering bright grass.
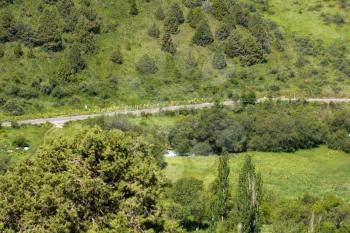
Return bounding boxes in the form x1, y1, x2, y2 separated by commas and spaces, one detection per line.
225, 30, 265, 66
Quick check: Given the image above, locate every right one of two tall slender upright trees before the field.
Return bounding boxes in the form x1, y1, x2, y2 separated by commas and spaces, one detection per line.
237, 156, 262, 233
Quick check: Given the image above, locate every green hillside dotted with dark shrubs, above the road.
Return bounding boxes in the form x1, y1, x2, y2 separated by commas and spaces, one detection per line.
0, 0, 350, 118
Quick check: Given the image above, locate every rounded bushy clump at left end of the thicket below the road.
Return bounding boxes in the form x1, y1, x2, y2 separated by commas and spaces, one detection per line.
169, 110, 247, 155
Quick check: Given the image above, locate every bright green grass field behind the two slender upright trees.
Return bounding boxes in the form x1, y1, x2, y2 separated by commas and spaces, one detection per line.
165, 147, 350, 201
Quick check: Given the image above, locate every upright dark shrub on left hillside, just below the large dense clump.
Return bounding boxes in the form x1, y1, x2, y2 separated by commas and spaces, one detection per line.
58, 45, 86, 81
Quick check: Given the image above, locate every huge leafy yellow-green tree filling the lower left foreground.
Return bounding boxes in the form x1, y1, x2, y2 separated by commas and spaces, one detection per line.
0, 128, 166, 232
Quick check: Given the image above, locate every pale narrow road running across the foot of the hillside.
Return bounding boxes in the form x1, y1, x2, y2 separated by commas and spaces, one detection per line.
3, 97, 350, 128
